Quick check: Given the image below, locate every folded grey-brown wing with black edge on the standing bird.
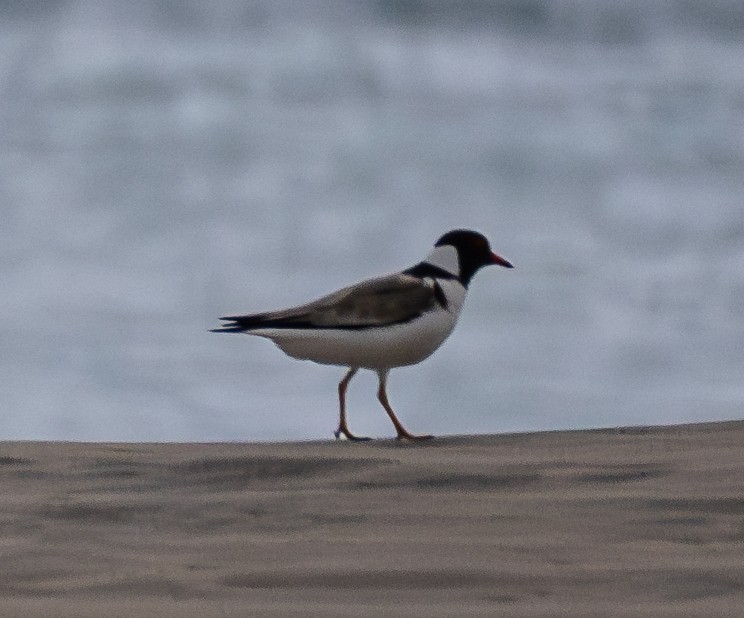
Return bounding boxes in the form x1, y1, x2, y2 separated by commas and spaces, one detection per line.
215, 275, 443, 332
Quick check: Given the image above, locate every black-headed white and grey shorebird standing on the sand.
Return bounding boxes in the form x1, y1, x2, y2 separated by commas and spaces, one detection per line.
211, 229, 513, 442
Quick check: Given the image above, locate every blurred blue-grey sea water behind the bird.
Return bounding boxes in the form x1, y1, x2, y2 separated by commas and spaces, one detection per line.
0, 0, 744, 441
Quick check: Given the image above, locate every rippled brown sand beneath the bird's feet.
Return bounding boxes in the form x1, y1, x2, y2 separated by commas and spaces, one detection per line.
0, 422, 744, 618
